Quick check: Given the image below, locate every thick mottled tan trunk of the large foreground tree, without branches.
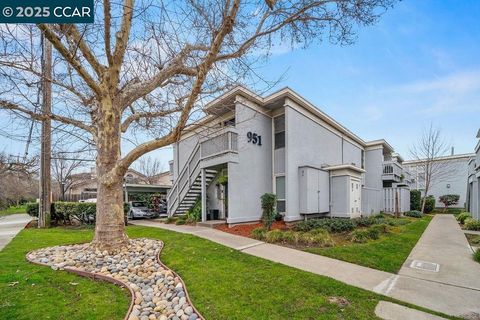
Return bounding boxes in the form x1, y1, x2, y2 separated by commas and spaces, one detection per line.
93, 98, 128, 252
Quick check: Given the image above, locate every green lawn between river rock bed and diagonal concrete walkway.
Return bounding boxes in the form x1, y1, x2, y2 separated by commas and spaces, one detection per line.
128, 226, 454, 319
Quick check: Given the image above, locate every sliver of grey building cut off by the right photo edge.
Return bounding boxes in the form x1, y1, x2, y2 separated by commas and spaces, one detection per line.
466, 130, 480, 220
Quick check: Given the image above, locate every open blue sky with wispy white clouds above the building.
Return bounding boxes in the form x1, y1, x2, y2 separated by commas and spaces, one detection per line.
0, 0, 480, 169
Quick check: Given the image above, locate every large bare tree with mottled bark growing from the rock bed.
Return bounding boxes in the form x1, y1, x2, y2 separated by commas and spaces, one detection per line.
0, 0, 395, 250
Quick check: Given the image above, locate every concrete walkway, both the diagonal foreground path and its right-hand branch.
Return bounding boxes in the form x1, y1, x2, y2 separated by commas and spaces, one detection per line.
134, 215, 480, 319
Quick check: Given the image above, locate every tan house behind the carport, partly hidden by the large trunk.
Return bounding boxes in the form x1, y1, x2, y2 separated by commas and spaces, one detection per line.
65, 167, 172, 201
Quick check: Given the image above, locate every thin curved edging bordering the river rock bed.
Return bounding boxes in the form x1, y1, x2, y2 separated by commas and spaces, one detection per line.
25, 239, 205, 320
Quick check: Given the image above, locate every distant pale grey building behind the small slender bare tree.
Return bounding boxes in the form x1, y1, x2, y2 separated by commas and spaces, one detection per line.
403, 153, 475, 208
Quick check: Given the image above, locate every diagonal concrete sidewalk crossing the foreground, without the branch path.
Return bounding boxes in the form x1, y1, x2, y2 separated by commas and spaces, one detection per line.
133, 218, 480, 319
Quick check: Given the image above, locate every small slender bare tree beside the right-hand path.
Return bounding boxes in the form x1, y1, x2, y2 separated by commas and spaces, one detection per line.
410, 125, 452, 212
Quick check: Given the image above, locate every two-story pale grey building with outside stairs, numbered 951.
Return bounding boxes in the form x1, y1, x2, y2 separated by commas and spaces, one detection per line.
168, 87, 409, 224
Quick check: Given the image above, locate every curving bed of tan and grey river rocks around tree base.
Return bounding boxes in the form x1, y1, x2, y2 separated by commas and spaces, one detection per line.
27, 238, 203, 320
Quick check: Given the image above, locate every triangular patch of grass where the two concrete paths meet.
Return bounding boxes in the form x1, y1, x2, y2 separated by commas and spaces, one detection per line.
305, 216, 432, 273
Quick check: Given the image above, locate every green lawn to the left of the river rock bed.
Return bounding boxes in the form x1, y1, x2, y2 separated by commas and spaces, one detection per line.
0, 228, 130, 320
